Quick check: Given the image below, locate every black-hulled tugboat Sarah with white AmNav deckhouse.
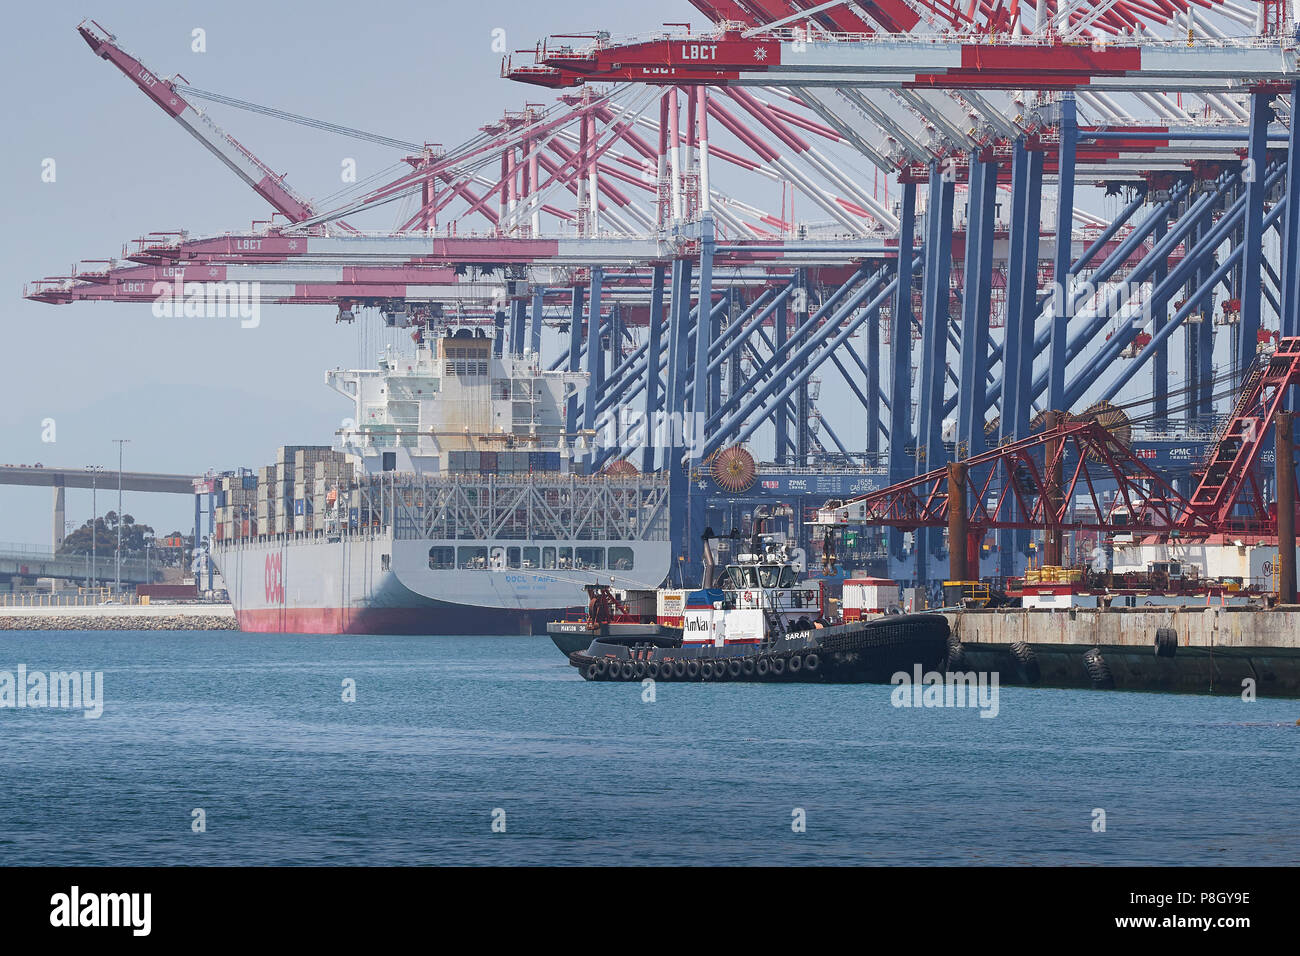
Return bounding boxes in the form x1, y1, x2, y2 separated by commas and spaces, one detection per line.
550, 522, 949, 683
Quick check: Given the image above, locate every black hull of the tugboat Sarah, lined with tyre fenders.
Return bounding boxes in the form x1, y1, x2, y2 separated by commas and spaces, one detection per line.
564, 614, 949, 683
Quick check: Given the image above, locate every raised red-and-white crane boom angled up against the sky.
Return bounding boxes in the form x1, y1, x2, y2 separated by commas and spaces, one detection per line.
77, 20, 316, 222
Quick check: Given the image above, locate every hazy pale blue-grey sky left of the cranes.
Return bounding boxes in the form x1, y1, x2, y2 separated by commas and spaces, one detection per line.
0, 0, 681, 546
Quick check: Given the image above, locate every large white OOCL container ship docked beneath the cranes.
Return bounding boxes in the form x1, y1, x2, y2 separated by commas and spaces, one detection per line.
209, 329, 670, 635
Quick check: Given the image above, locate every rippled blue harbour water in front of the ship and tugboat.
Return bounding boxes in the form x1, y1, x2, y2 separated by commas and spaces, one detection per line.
0, 632, 1300, 865
